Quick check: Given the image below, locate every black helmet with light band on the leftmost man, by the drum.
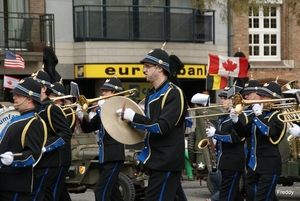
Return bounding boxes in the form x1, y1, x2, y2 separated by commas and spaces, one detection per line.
10, 77, 41, 103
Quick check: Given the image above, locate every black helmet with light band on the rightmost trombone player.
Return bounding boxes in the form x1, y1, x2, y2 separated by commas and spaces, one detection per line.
257, 81, 281, 99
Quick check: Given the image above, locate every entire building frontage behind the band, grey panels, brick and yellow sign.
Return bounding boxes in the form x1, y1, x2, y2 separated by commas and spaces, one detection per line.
0, 0, 300, 103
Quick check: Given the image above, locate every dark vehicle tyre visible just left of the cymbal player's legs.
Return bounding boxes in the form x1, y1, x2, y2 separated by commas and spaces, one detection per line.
118, 173, 135, 201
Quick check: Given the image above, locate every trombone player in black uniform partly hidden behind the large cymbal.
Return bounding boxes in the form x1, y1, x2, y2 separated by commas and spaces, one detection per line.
76, 77, 125, 201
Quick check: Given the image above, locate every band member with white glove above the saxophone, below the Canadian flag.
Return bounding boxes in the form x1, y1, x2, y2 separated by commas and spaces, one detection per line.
206, 86, 245, 201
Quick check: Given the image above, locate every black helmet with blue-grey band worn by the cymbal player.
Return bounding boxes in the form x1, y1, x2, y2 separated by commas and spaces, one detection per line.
140, 48, 170, 75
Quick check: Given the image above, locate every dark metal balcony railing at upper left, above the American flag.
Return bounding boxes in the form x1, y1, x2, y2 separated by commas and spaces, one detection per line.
0, 12, 55, 51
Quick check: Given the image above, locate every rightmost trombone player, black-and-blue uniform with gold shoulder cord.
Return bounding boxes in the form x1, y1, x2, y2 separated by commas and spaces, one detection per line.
234, 82, 286, 201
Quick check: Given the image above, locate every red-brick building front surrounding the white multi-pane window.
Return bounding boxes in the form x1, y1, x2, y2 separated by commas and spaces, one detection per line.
233, 0, 300, 84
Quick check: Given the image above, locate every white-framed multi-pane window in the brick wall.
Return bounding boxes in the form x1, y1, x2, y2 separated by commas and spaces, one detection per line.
249, 5, 281, 61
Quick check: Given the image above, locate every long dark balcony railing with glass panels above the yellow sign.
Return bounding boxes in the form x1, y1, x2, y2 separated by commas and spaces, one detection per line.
73, 5, 215, 44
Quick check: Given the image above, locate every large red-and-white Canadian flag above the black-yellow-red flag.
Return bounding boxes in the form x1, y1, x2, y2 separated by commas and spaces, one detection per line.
207, 54, 248, 78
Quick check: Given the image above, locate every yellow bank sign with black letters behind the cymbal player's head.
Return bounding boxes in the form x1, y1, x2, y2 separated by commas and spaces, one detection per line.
74, 64, 206, 79
